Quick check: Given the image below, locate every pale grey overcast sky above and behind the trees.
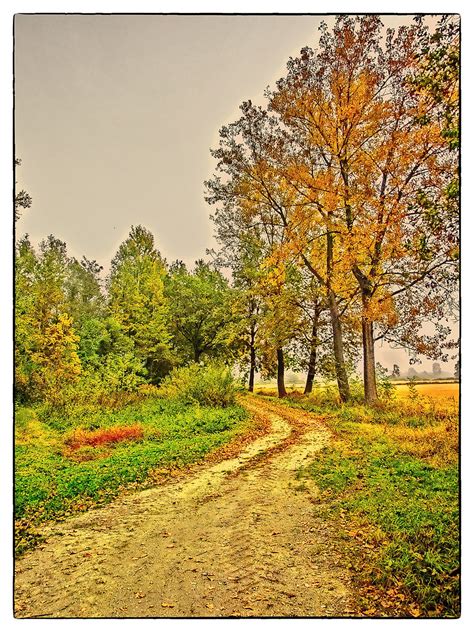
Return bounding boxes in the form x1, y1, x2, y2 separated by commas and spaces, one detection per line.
15, 15, 458, 369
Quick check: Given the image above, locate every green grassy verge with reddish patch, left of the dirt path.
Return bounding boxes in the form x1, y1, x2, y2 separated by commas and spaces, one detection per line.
15, 397, 252, 553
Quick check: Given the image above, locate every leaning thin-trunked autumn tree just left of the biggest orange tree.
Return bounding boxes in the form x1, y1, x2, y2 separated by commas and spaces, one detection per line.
206, 102, 349, 401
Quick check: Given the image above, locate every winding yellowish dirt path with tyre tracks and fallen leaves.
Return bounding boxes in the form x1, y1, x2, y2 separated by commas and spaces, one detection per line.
15, 397, 352, 617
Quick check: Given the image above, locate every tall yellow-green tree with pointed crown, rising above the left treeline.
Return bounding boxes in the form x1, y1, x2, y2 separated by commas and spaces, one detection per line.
108, 226, 174, 383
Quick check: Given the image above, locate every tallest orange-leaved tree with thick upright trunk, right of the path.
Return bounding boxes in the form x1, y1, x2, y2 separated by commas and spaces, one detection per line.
269, 16, 453, 402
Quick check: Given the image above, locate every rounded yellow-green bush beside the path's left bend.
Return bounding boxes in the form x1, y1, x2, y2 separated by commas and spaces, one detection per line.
160, 363, 237, 408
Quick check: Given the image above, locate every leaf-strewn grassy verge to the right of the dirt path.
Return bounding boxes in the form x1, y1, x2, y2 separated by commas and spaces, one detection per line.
274, 398, 460, 617
